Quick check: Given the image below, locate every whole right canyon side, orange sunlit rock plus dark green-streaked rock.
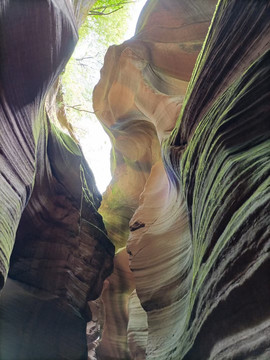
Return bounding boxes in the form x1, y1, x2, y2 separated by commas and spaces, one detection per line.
93, 0, 270, 360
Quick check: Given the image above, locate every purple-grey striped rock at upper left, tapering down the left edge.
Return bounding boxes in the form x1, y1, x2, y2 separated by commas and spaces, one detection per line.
0, 1, 77, 287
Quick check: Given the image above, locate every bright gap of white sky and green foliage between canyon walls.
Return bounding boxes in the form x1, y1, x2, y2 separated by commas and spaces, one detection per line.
58, 0, 141, 190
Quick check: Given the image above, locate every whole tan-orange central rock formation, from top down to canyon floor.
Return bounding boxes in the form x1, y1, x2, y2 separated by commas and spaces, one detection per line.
93, 1, 214, 359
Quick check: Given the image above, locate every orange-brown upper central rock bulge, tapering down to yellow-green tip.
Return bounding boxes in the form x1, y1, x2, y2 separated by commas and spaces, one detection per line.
93, 0, 215, 248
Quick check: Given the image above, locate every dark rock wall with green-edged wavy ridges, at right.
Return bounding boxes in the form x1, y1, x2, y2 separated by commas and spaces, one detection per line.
165, 1, 270, 360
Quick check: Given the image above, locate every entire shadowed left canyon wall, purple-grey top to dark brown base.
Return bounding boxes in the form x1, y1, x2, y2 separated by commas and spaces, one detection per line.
0, 0, 114, 360
